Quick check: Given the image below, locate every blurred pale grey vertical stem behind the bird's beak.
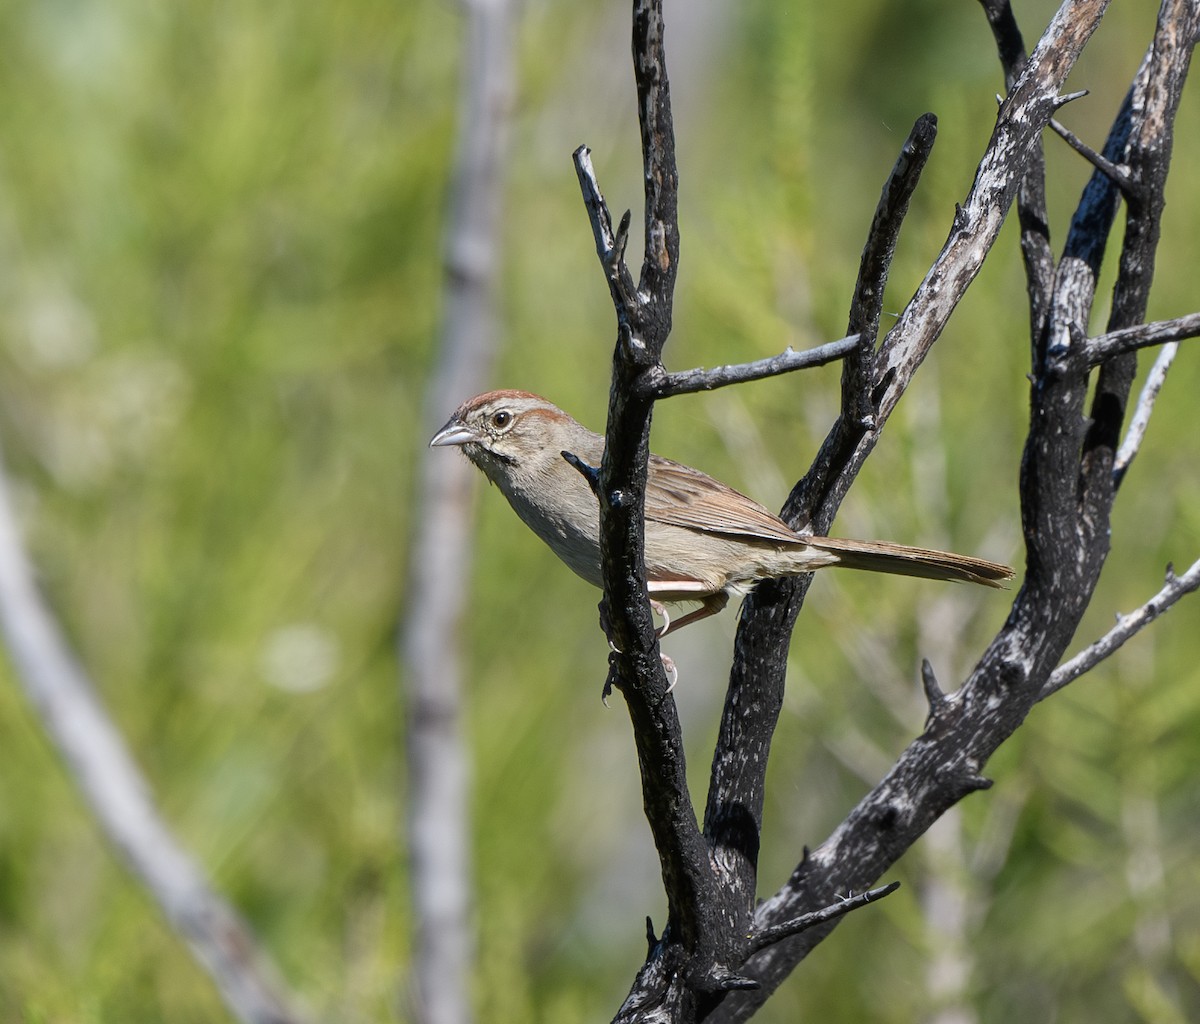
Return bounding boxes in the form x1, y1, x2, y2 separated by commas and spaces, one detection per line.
401, 0, 516, 1024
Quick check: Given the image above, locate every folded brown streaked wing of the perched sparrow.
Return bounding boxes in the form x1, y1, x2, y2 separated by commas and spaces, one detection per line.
646, 455, 802, 544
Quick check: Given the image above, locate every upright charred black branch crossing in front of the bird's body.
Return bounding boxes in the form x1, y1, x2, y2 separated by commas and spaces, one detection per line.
569, 0, 719, 1004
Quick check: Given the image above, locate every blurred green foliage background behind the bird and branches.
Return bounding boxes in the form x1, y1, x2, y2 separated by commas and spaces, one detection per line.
0, 0, 1200, 1024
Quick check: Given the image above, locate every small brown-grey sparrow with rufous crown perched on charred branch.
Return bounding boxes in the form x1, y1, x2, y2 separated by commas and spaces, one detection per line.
430, 391, 1013, 636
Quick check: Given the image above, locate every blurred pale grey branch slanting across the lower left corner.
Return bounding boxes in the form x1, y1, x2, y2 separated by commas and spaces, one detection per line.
0, 451, 305, 1024
